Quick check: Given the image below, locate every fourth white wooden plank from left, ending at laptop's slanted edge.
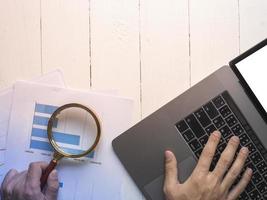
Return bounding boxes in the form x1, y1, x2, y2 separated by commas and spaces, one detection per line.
140, 0, 190, 117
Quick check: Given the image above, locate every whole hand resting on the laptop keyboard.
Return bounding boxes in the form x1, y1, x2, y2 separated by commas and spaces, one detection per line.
163, 131, 252, 200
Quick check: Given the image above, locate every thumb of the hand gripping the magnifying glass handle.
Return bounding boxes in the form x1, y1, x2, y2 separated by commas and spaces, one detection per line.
44, 170, 59, 200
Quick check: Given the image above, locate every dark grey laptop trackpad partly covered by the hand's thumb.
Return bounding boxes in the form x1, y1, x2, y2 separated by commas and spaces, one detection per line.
144, 156, 196, 200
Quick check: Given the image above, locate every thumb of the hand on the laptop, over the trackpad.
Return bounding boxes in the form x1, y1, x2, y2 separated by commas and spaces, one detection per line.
164, 151, 179, 188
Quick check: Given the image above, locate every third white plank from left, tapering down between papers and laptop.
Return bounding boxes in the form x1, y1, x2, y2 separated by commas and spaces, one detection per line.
91, 0, 141, 122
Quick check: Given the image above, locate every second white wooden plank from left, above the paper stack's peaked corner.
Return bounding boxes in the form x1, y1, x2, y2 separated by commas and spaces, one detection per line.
41, 0, 90, 88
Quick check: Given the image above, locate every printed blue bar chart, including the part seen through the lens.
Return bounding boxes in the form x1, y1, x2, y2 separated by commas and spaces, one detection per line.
30, 103, 97, 158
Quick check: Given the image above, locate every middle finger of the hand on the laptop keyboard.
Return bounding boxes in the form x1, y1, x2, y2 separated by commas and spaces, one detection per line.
213, 136, 239, 179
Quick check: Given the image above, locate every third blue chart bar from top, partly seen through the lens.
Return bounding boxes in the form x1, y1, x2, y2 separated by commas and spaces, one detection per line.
32, 128, 80, 145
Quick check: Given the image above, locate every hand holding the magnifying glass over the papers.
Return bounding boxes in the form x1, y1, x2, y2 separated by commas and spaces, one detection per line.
1, 162, 59, 200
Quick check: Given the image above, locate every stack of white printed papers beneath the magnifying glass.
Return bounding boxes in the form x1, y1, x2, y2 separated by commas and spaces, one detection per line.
0, 70, 133, 200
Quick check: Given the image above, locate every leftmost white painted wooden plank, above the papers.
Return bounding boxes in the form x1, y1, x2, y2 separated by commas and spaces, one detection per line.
0, 0, 41, 88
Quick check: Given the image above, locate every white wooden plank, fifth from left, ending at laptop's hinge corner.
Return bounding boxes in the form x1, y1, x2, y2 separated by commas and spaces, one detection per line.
190, 0, 239, 84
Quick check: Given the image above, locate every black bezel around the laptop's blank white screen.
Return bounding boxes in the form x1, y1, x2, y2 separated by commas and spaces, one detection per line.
229, 38, 267, 123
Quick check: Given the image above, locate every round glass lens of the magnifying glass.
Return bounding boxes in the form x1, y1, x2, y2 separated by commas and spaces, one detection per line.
51, 107, 97, 157
